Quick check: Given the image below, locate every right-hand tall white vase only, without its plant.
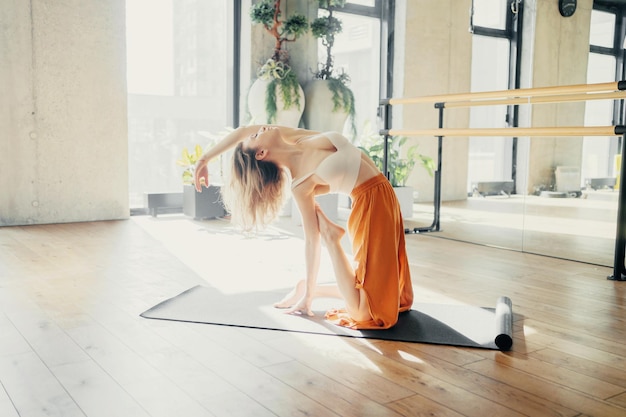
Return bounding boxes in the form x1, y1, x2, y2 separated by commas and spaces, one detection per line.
303, 80, 348, 133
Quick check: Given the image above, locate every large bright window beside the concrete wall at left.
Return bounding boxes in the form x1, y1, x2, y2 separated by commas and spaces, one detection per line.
126, 0, 234, 209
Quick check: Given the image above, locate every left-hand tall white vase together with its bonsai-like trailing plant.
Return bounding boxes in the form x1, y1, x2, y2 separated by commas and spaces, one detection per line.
248, 0, 309, 127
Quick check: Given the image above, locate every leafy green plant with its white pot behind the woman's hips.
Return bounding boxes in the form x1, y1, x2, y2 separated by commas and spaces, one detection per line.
360, 123, 435, 218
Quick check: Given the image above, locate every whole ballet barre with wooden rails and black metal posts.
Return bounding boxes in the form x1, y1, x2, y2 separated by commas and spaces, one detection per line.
380, 80, 626, 281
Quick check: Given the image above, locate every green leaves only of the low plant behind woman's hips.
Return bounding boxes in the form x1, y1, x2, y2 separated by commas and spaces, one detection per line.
359, 122, 435, 187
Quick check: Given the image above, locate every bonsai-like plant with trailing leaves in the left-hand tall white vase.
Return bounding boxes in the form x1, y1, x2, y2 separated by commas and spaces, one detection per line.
250, 0, 309, 123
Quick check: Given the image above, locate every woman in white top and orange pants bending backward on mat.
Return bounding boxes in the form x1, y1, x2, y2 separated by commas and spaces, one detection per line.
195, 126, 413, 329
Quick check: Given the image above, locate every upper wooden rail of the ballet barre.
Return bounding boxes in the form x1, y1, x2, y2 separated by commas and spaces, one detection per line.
380, 81, 626, 105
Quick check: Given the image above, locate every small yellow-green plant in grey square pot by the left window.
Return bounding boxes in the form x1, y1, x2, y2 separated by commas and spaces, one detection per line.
176, 145, 226, 219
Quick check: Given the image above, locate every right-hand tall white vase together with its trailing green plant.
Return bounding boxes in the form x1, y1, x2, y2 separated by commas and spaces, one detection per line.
304, 0, 356, 137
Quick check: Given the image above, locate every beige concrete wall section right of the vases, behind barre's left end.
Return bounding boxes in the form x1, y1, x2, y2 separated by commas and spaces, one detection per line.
393, 0, 472, 201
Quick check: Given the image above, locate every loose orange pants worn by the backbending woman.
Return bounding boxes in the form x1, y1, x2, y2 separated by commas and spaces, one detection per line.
326, 174, 413, 329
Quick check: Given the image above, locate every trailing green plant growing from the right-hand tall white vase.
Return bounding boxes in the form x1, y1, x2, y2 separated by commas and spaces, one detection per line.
311, 0, 356, 136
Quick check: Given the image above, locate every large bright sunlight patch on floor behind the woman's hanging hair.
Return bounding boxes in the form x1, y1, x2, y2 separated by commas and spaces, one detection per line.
132, 215, 333, 294
